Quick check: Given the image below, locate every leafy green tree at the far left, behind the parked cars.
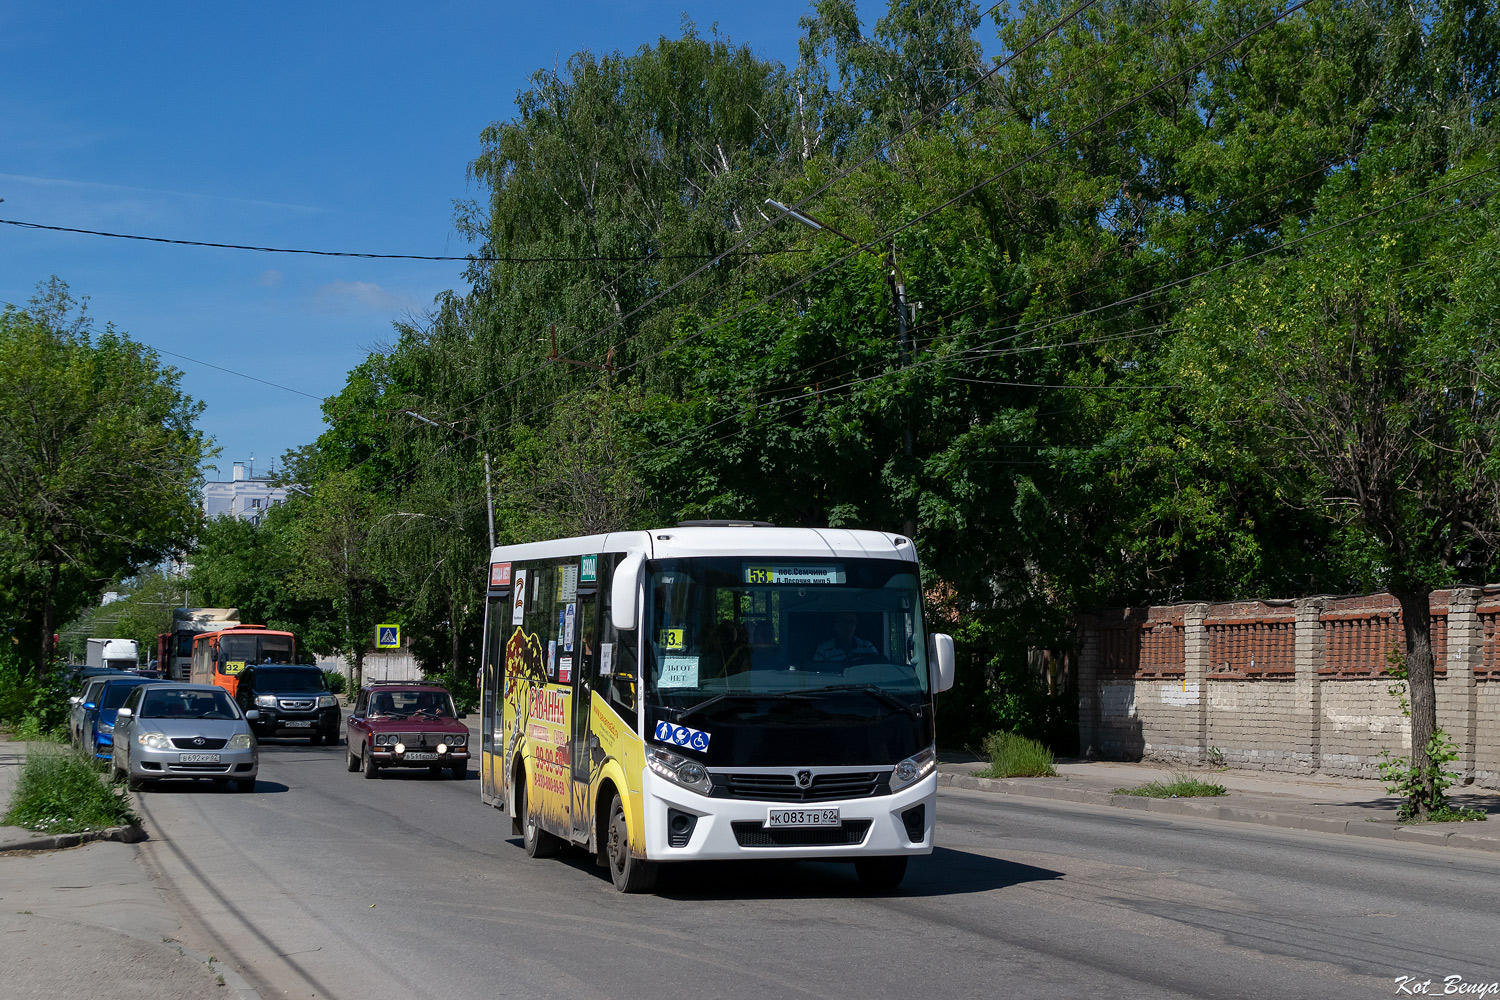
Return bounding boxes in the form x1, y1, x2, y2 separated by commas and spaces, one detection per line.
0, 277, 206, 675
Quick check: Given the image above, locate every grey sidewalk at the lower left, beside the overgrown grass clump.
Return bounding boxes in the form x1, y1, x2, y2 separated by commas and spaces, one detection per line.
0, 739, 258, 1000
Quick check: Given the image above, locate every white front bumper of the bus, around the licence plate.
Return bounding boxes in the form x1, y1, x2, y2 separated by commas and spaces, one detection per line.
642, 769, 938, 861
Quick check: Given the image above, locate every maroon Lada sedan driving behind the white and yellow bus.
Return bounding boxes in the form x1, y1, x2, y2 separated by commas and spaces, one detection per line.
347, 681, 468, 781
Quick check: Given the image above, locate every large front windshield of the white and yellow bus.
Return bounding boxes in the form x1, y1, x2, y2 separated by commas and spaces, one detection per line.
642, 556, 929, 709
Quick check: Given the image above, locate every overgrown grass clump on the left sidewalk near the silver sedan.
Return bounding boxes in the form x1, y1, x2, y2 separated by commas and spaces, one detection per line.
0, 747, 140, 834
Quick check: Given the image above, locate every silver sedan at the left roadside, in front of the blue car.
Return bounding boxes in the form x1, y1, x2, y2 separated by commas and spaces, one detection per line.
111, 684, 260, 792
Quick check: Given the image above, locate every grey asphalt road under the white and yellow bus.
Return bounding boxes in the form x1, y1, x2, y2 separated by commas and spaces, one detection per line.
129, 742, 1500, 1000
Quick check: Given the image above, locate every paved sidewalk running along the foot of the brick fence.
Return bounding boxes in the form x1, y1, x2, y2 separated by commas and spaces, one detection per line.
938, 754, 1500, 853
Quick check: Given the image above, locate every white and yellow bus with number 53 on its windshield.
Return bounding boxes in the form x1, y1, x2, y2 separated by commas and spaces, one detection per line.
480, 522, 954, 892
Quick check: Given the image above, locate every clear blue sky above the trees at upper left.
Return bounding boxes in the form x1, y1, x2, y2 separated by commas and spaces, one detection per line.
0, 0, 885, 478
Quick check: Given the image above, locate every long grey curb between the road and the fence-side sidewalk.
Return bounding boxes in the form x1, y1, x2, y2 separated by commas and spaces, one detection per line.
938, 771, 1500, 853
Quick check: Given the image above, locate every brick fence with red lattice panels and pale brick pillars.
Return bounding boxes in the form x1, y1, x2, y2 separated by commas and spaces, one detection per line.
1077, 586, 1500, 787
